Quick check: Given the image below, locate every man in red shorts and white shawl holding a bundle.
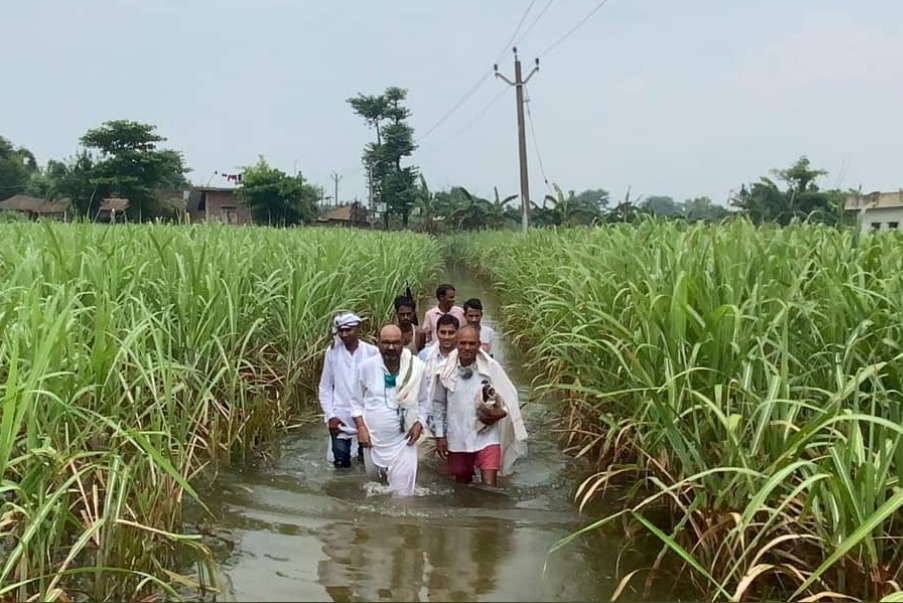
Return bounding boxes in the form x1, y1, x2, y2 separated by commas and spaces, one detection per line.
432, 326, 527, 486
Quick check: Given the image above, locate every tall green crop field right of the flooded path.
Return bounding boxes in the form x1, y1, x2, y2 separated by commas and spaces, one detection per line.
447, 220, 903, 600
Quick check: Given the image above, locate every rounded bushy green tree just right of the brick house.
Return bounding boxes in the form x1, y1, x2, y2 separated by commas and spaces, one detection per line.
238, 155, 323, 226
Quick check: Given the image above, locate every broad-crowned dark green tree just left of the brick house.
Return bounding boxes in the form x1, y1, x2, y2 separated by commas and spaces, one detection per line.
81, 120, 189, 220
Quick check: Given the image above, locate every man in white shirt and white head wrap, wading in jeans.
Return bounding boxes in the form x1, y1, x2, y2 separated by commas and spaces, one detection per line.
319, 312, 379, 468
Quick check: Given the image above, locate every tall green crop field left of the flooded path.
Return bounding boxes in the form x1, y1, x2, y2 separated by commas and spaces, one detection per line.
0, 224, 441, 601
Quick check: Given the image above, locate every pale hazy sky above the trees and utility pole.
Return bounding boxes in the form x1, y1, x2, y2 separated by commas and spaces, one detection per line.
0, 0, 903, 203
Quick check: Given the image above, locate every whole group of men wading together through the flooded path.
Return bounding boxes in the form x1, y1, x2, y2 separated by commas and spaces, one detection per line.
319, 284, 527, 495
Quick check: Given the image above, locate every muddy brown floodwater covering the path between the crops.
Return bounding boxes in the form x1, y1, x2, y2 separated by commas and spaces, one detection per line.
198, 274, 688, 601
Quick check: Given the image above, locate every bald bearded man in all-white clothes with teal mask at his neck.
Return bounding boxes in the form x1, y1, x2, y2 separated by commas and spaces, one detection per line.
351, 325, 430, 496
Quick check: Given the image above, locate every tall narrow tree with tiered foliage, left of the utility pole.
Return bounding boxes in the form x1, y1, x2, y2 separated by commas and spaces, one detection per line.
347, 87, 418, 228
